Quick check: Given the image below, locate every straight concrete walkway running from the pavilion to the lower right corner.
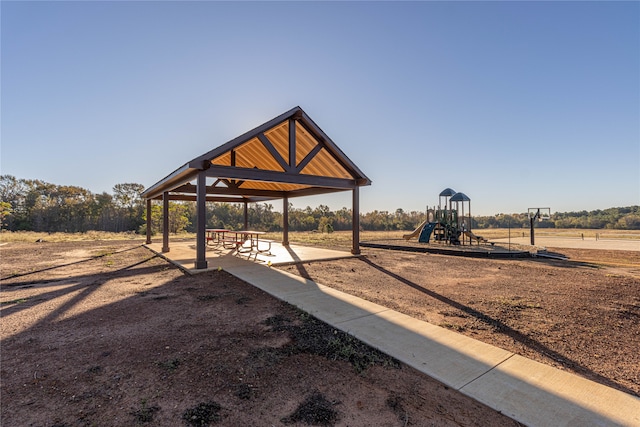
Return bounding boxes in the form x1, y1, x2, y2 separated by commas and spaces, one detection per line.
148, 245, 640, 427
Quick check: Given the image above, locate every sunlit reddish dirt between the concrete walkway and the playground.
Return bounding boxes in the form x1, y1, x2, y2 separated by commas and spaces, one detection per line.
276, 248, 640, 396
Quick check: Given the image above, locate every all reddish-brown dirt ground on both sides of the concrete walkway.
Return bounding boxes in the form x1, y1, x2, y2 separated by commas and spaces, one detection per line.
0, 241, 640, 427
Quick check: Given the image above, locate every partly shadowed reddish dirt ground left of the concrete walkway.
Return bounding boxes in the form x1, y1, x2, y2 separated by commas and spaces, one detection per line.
0, 242, 517, 427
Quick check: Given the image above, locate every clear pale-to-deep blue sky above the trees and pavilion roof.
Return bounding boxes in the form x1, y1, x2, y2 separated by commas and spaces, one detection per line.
0, 1, 640, 215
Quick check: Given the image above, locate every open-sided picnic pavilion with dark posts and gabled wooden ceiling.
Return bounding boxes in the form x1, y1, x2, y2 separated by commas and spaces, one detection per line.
142, 107, 371, 269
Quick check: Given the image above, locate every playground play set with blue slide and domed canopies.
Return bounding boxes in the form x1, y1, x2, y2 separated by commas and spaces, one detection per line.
402, 188, 492, 245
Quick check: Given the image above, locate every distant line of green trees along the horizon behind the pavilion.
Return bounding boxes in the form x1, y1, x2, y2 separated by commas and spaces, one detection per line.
0, 175, 640, 234
